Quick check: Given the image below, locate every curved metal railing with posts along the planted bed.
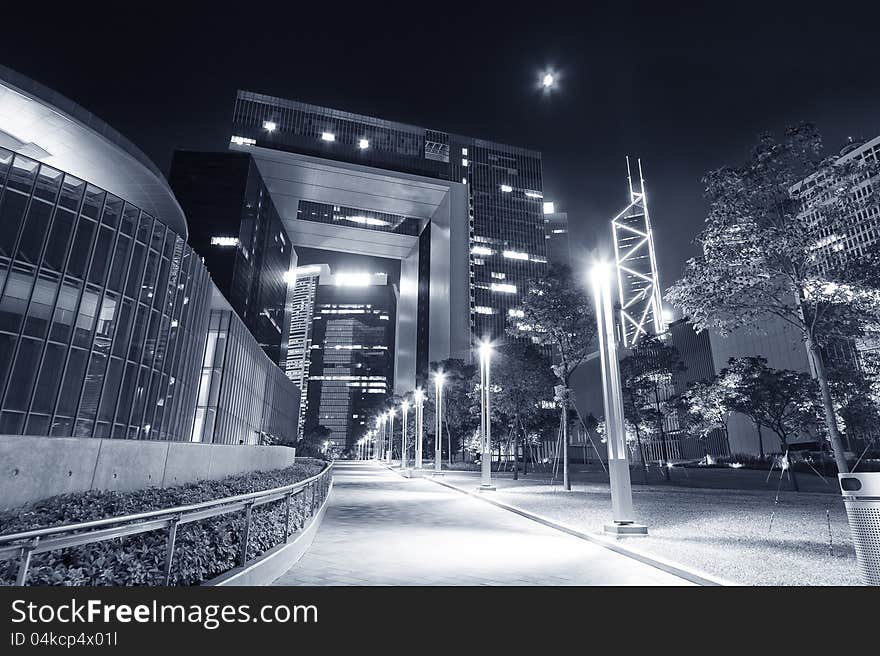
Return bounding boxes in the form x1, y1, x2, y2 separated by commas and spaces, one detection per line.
0, 463, 333, 586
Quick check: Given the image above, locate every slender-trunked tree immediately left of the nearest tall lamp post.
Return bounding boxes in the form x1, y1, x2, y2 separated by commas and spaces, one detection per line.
507, 265, 597, 490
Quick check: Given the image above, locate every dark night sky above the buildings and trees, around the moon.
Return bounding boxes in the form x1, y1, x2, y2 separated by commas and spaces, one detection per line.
0, 0, 880, 287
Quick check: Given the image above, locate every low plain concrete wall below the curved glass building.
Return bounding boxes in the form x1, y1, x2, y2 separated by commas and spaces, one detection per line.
0, 435, 296, 508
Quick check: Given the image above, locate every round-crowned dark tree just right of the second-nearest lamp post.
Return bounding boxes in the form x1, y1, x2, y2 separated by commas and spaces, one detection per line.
492, 341, 555, 480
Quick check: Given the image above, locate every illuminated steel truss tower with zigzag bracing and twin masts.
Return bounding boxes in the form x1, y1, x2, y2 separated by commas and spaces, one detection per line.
611, 156, 666, 348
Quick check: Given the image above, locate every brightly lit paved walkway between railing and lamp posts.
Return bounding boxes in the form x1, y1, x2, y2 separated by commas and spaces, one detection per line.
275, 462, 688, 585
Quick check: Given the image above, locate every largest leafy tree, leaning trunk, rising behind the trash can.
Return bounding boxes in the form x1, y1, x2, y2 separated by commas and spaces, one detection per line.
667, 124, 880, 472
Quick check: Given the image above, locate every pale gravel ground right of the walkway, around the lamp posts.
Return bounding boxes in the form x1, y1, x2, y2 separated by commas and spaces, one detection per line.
436, 472, 860, 585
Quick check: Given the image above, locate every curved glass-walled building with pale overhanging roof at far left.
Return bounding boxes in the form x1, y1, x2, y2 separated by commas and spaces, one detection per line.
0, 67, 298, 443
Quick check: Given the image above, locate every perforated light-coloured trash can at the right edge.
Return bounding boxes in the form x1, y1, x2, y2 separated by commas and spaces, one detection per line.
837, 472, 880, 585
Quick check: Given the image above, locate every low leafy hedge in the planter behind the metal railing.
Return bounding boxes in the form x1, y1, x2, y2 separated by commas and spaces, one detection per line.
0, 460, 327, 585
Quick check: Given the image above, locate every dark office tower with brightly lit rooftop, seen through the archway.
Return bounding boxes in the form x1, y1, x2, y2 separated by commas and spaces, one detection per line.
288, 265, 397, 448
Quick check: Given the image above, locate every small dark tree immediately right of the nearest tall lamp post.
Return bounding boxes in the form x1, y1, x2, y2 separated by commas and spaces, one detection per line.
620, 335, 685, 480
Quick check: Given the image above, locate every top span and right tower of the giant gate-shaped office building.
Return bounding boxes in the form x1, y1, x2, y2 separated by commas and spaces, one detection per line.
223, 91, 547, 392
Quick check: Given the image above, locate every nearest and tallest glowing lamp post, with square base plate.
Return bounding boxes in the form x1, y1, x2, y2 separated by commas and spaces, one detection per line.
590, 262, 648, 535
